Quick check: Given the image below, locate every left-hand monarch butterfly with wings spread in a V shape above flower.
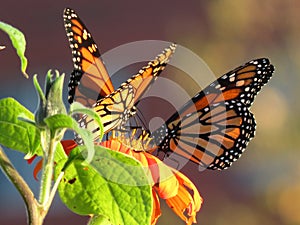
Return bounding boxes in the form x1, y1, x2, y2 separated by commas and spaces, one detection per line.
64, 8, 176, 141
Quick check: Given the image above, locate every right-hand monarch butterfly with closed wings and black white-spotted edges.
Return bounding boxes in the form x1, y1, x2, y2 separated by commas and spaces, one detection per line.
145, 58, 274, 170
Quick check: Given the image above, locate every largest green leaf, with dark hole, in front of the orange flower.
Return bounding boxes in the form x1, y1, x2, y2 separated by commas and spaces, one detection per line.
56, 146, 152, 225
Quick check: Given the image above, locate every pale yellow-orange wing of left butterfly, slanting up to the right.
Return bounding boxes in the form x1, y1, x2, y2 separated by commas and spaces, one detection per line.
78, 44, 176, 140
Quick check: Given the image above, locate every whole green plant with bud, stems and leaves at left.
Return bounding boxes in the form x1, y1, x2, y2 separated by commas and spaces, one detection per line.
0, 23, 152, 225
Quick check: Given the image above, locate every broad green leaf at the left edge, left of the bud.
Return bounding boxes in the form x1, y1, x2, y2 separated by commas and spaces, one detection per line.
0, 98, 42, 155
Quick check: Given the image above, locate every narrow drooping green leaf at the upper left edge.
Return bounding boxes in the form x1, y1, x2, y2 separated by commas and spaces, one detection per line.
0, 21, 28, 78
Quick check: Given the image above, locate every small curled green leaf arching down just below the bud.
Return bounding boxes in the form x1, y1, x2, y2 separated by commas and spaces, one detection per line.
44, 114, 95, 162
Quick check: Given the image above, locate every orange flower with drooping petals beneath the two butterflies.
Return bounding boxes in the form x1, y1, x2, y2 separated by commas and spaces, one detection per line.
62, 138, 202, 225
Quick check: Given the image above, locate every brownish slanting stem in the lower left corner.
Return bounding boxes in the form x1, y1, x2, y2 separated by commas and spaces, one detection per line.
0, 147, 42, 225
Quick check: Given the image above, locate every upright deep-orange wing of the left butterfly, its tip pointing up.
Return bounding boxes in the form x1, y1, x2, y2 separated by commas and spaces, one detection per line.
64, 8, 114, 107
